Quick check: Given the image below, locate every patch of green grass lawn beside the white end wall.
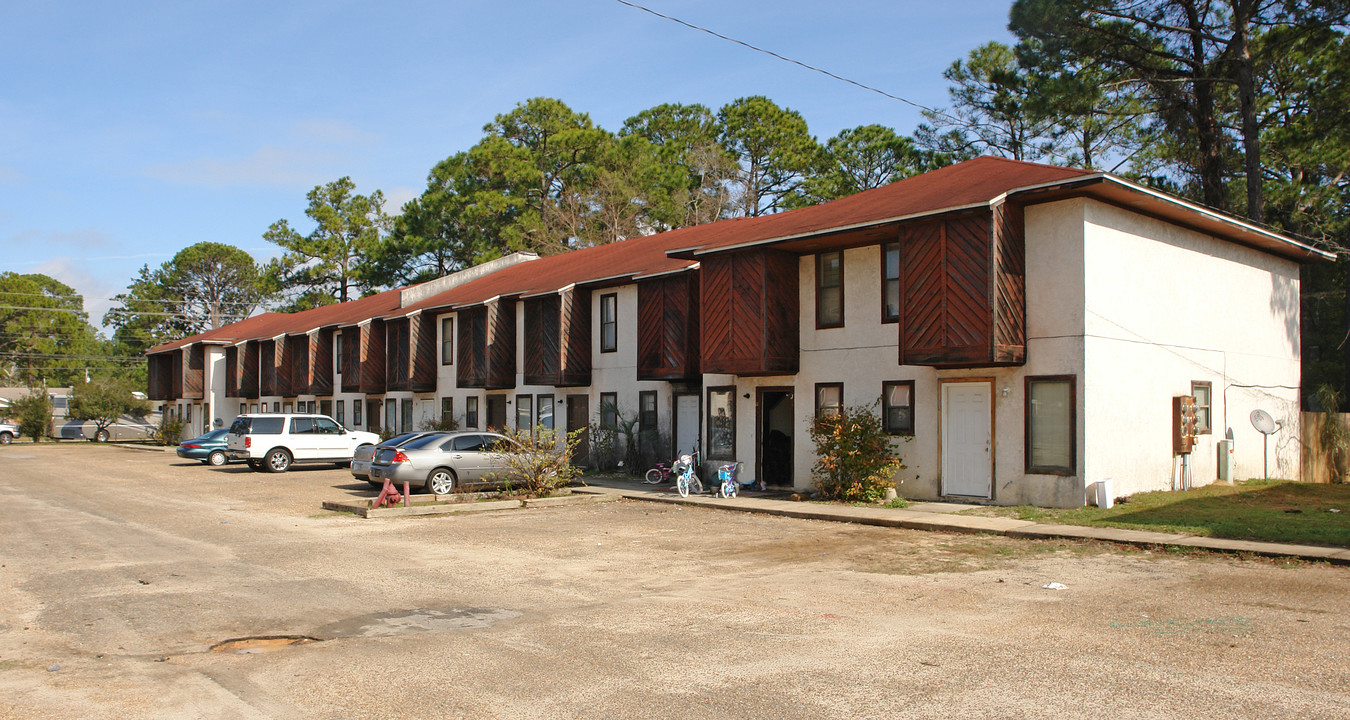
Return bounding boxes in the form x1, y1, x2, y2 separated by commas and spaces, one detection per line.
964, 480, 1350, 547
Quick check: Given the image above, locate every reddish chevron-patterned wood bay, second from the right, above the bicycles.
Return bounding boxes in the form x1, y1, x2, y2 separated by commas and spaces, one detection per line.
699, 250, 799, 376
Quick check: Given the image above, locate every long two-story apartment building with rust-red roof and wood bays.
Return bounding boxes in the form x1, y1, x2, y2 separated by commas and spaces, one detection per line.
149, 158, 1330, 507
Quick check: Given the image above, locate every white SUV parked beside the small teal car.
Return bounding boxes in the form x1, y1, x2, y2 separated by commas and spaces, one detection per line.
227, 413, 379, 473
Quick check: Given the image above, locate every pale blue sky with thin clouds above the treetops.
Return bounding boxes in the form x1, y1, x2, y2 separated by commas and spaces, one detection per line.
0, 0, 1011, 326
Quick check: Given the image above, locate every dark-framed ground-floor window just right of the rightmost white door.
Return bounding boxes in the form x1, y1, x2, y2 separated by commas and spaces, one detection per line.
1026, 376, 1077, 475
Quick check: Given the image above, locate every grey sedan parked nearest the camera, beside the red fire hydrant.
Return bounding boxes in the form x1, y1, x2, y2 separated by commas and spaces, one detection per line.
370, 432, 510, 494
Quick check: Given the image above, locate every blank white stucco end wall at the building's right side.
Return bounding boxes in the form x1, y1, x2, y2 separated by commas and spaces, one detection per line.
1077, 200, 1300, 493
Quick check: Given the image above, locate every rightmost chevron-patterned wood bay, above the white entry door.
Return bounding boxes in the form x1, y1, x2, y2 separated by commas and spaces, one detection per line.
899, 211, 1026, 367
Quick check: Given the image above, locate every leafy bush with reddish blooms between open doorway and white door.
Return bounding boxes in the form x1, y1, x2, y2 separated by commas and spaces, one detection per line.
810, 405, 905, 503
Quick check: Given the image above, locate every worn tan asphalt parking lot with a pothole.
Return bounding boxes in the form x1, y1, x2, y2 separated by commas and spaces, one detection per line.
0, 443, 1350, 719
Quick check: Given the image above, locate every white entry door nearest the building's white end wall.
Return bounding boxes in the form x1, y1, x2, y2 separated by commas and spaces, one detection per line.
942, 382, 994, 498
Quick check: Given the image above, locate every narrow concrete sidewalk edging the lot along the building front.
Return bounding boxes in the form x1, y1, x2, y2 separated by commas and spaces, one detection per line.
572, 478, 1350, 565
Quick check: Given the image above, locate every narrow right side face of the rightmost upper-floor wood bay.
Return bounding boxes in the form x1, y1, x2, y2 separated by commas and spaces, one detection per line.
994, 204, 1026, 365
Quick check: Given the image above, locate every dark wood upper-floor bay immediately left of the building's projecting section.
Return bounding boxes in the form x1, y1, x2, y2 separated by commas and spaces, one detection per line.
637, 273, 698, 381
